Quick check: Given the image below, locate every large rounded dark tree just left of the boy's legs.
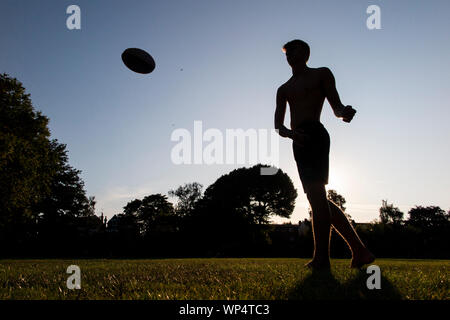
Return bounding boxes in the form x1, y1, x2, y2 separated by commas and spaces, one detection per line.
177, 165, 297, 256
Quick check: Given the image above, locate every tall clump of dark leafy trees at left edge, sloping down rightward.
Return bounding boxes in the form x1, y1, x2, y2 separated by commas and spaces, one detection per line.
0, 74, 95, 248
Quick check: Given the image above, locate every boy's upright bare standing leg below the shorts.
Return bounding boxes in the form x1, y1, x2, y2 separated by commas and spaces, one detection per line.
307, 184, 331, 269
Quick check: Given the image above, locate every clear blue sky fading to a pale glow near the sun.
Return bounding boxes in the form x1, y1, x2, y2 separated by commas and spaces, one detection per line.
0, 0, 450, 222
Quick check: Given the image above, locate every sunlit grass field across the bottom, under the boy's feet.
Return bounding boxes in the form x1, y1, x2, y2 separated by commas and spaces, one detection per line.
0, 258, 450, 300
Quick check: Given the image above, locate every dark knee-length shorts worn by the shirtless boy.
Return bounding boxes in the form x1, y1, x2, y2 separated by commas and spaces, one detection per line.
292, 122, 330, 193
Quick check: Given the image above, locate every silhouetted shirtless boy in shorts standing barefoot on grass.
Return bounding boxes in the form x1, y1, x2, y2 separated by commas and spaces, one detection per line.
275, 40, 375, 269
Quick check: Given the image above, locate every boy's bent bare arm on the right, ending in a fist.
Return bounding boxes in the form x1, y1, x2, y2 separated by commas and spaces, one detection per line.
322, 68, 356, 122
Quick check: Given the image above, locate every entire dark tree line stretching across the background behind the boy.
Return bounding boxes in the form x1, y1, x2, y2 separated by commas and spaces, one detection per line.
0, 74, 450, 258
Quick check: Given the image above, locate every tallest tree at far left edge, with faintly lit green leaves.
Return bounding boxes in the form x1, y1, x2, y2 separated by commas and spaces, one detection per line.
0, 74, 55, 229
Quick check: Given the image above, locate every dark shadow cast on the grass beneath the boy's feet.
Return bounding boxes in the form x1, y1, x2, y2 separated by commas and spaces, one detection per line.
288, 270, 402, 300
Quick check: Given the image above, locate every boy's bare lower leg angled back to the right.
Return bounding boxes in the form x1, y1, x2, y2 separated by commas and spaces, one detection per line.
328, 201, 375, 268
